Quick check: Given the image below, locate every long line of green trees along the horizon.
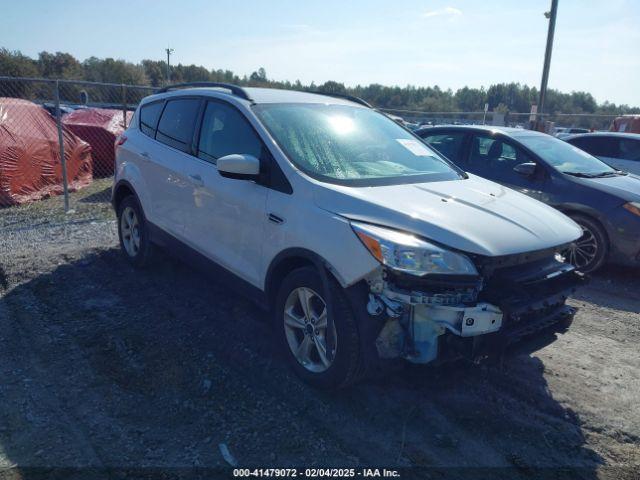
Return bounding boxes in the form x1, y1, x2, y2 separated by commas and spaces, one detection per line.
0, 48, 640, 115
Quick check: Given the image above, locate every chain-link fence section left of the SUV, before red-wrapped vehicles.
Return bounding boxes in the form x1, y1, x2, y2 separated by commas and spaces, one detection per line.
0, 77, 154, 248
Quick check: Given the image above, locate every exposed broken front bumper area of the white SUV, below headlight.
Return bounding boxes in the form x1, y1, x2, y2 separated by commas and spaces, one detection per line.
373, 272, 585, 363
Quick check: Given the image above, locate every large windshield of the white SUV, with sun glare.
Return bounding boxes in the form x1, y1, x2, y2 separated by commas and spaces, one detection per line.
254, 103, 463, 185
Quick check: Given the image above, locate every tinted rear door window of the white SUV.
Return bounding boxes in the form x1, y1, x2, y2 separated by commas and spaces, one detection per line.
156, 98, 200, 152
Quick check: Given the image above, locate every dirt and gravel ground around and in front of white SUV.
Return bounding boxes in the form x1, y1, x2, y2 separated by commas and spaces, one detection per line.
0, 215, 640, 479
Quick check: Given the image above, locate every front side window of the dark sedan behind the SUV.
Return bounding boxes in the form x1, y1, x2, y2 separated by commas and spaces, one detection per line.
468, 135, 534, 183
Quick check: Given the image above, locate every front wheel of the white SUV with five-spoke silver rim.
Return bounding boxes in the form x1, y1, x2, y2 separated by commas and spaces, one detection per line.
274, 267, 360, 389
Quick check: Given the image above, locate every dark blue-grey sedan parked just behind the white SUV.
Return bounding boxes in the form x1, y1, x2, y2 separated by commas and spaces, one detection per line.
416, 126, 640, 272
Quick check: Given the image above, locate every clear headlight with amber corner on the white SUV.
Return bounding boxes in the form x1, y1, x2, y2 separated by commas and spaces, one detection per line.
351, 222, 478, 276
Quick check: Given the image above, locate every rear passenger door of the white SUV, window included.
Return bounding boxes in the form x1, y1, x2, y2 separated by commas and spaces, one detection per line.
141, 97, 200, 239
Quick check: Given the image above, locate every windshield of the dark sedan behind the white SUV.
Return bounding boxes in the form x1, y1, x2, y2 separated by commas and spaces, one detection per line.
517, 135, 616, 177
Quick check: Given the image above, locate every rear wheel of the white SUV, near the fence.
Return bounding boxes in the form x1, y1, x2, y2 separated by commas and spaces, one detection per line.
118, 195, 153, 267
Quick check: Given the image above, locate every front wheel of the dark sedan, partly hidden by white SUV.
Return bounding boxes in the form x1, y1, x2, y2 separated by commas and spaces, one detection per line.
563, 214, 609, 273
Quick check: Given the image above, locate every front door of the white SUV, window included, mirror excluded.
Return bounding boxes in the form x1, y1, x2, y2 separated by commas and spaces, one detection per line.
184, 99, 270, 286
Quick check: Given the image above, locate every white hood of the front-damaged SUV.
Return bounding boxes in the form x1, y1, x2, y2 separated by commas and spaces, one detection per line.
314, 175, 582, 256
